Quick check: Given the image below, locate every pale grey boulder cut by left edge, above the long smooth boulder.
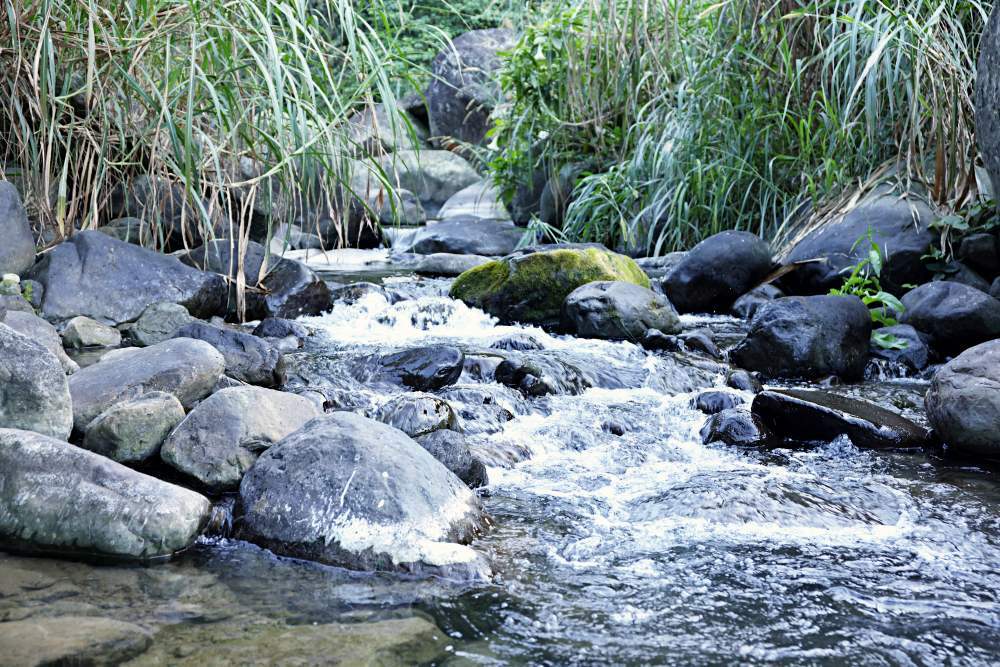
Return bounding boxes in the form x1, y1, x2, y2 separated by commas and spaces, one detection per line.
0, 324, 73, 444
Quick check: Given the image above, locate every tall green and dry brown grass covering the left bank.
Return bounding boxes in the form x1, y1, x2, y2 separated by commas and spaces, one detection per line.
0, 0, 402, 266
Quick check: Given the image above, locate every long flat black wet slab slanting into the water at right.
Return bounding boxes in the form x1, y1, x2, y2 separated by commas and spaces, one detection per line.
751, 389, 929, 449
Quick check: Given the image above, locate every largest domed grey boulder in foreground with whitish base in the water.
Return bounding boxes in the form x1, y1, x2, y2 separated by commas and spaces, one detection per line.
239, 412, 488, 578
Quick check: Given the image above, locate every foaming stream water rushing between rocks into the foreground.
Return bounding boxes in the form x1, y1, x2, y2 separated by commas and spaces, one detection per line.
0, 268, 1000, 665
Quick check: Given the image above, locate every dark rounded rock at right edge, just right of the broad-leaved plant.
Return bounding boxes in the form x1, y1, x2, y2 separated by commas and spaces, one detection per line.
900, 281, 1000, 355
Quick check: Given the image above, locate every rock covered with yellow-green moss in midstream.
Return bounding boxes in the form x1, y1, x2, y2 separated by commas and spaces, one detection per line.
451, 247, 649, 327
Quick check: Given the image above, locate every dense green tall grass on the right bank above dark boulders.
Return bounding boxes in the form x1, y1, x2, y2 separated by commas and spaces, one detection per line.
493, 0, 991, 254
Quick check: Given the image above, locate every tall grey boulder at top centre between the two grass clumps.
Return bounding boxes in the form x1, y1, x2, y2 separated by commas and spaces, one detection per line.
427, 28, 515, 144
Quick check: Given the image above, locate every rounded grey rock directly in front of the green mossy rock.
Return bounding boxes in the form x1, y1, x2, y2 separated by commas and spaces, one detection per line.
562, 281, 681, 341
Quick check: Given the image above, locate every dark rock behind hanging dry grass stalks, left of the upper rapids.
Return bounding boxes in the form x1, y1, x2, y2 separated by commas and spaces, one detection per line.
181, 239, 331, 320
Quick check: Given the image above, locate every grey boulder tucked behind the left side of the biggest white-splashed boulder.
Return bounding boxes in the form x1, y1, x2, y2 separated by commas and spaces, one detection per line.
160, 387, 320, 491
